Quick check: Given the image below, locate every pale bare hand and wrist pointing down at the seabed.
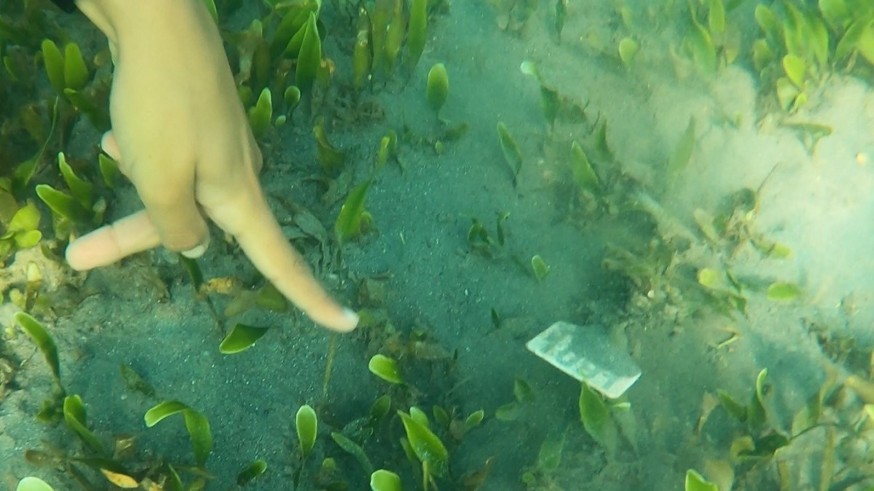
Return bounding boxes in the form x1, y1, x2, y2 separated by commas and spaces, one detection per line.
67, 0, 358, 332
